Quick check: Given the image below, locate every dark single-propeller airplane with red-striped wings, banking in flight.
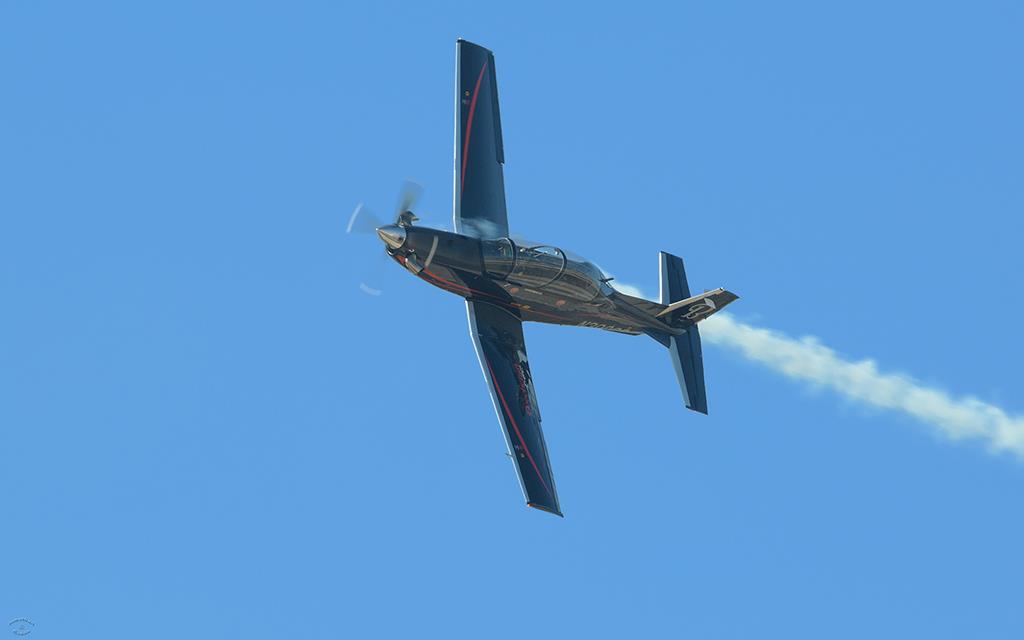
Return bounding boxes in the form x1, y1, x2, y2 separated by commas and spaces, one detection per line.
358, 39, 737, 516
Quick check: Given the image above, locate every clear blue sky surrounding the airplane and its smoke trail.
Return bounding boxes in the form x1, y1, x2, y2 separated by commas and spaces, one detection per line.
0, 0, 1024, 639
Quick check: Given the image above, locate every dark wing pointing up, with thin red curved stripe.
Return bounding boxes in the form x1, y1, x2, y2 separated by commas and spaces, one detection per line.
455, 40, 509, 238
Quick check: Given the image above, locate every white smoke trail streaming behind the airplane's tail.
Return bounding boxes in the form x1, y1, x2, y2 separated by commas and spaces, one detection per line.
700, 313, 1024, 459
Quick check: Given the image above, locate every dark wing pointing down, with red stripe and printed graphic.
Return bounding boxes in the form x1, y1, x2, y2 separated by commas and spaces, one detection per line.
466, 300, 562, 516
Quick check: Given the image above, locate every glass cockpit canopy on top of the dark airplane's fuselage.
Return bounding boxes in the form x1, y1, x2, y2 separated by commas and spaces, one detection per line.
481, 238, 607, 301
